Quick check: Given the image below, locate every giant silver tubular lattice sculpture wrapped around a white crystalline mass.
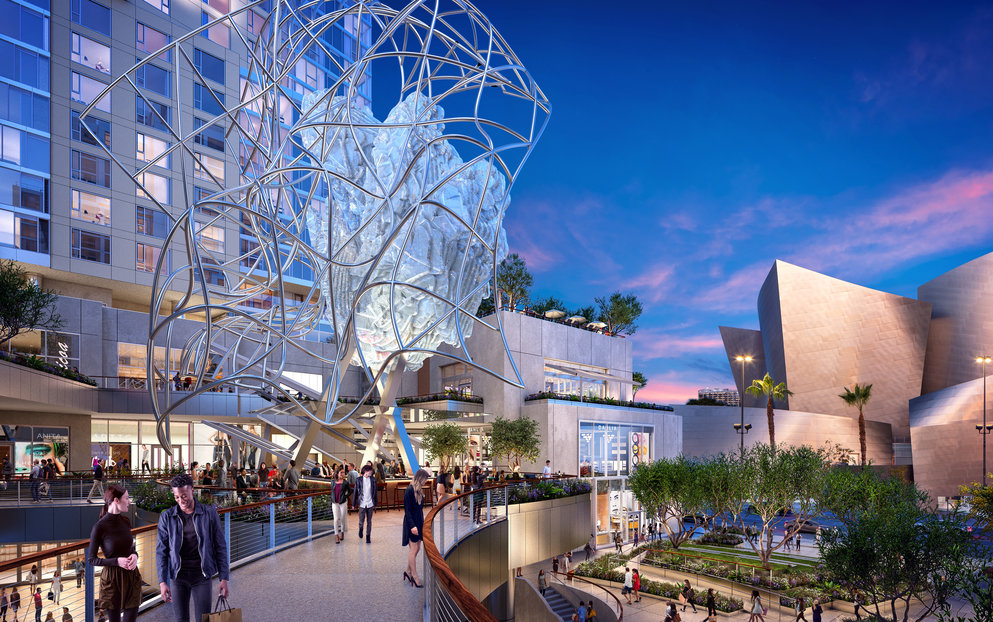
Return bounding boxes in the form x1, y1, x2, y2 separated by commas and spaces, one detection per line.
80, 0, 550, 449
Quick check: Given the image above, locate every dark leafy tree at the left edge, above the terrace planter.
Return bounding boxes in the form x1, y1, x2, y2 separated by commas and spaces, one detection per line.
0, 259, 62, 344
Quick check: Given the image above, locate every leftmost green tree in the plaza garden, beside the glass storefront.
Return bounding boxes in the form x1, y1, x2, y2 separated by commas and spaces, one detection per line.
628, 456, 707, 549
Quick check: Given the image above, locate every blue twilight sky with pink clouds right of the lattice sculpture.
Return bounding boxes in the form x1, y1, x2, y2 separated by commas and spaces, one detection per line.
452, 0, 993, 402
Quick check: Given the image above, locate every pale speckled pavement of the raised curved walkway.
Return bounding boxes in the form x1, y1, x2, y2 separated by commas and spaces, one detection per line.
138, 510, 424, 622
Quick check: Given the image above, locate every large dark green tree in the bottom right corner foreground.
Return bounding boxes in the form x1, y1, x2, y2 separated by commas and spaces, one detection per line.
819, 467, 975, 622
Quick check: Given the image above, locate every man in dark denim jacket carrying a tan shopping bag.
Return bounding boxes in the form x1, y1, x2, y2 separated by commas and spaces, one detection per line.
155, 473, 230, 622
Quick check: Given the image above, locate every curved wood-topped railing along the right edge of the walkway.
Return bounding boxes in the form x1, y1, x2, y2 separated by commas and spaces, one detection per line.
422, 475, 576, 622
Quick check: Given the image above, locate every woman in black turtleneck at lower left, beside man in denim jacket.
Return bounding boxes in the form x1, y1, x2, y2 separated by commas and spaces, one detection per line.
86, 484, 141, 622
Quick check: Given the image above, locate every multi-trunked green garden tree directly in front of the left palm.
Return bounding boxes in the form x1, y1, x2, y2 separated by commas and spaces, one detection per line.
728, 443, 827, 568
